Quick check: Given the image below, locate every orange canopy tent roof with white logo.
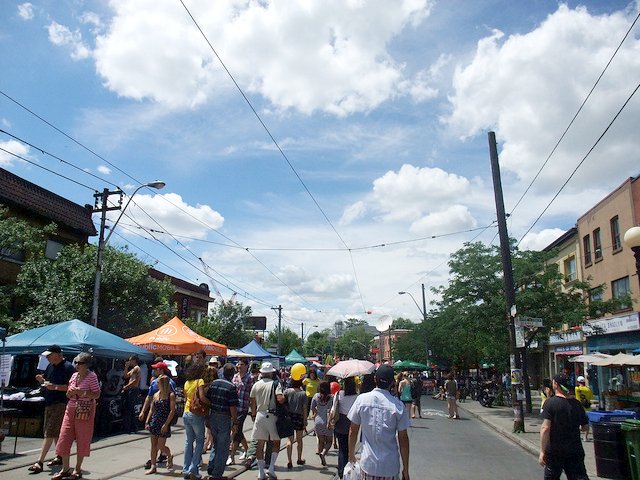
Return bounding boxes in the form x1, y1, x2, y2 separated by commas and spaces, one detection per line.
127, 317, 227, 356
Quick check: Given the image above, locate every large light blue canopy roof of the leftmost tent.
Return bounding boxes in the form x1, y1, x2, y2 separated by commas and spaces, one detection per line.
5, 320, 153, 361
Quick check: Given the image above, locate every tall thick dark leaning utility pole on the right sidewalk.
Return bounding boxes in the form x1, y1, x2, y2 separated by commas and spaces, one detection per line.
489, 132, 527, 433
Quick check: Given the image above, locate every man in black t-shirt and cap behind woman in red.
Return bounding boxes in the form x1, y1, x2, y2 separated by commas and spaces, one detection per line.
29, 345, 76, 473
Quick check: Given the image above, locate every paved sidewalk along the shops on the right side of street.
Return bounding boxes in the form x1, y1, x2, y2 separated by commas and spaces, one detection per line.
458, 399, 601, 479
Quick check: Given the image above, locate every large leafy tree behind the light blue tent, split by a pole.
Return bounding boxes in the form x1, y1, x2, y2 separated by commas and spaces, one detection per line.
15, 245, 173, 338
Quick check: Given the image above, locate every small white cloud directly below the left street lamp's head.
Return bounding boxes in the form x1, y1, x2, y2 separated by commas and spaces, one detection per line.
109, 193, 224, 242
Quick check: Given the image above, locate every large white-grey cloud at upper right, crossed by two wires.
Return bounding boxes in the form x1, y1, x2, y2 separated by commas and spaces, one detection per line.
446, 5, 640, 194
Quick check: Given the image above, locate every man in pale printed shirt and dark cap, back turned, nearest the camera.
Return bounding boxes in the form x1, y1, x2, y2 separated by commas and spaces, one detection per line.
348, 365, 411, 480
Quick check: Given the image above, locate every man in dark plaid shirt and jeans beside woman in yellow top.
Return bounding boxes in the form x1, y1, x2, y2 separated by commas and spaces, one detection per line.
207, 363, 238, 480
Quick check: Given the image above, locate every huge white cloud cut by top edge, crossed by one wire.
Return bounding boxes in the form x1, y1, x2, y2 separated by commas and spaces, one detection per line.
95, 0, 433, 116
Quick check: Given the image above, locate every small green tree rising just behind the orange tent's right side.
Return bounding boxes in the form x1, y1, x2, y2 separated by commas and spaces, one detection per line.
185, 300, 254, 348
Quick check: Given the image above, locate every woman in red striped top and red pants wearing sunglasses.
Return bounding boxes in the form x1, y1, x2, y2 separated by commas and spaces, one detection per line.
51, 352, 100, 480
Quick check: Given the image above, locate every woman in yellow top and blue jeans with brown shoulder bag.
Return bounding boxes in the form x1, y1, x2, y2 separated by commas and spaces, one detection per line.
182, 364, 209, 480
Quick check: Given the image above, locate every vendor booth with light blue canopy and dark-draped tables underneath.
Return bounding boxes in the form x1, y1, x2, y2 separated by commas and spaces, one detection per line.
3, 320, 153, 436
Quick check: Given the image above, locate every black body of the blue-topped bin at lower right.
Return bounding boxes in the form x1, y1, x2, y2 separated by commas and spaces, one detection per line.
591, 422, 630, 480
